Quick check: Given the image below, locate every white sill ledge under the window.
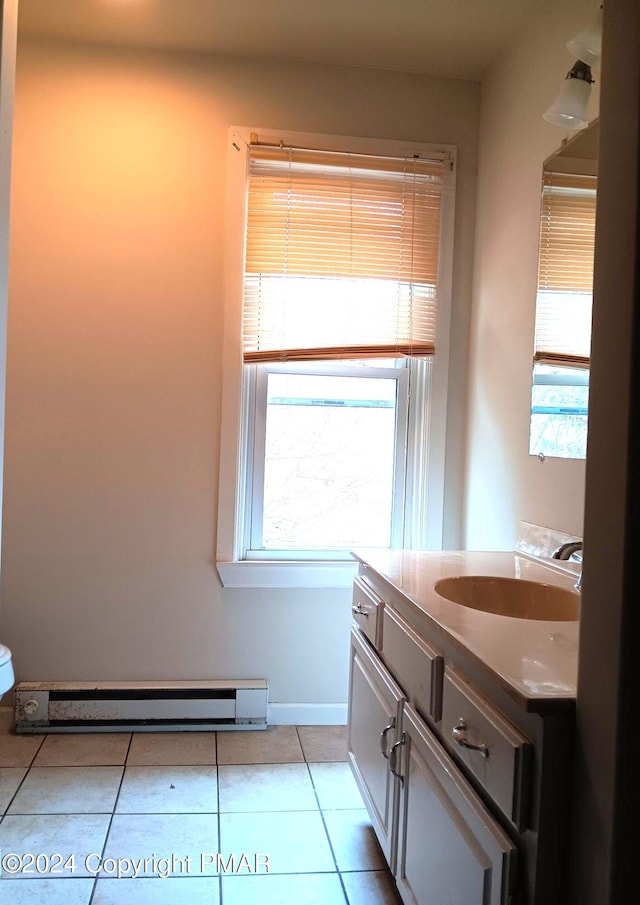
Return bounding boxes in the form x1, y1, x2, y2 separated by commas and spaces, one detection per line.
216, 560, 358, 588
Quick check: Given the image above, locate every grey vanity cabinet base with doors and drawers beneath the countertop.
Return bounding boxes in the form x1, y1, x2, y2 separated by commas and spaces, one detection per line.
348, 565, 571, 905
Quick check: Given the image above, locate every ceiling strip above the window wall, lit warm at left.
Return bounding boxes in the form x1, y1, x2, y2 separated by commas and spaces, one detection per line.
19, 0, 542, 80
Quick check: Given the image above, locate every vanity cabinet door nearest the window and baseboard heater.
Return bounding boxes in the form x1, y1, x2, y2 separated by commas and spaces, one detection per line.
348, 629, 403, 870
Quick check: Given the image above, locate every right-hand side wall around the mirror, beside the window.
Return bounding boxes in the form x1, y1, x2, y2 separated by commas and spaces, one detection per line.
465, 0, 600, 550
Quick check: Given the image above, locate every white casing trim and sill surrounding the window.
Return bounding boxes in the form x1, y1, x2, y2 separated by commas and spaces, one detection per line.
216, 127, 456, 588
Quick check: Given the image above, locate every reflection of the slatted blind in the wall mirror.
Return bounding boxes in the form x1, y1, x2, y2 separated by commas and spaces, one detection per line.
534, 173, 597, 367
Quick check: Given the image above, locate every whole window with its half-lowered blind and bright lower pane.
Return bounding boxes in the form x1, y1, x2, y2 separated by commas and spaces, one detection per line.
218, 133, 454, 583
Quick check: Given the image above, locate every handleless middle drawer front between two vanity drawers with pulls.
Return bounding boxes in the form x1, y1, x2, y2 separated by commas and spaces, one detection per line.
382, 606, 443, 722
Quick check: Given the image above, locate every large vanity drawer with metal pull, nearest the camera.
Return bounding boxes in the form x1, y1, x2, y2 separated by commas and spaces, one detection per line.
442, 666, 532, 830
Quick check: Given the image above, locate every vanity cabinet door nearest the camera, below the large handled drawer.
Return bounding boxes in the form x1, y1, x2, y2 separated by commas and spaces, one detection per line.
396, 705, 516, 905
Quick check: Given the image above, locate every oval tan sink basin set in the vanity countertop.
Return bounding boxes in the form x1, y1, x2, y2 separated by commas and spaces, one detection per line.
434, 575, 580, 622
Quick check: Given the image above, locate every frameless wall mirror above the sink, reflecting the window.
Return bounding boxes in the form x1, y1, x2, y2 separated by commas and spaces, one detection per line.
529, 120, 599, 459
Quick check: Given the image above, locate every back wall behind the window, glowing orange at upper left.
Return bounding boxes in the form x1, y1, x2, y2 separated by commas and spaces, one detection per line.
2, 42, 479, 705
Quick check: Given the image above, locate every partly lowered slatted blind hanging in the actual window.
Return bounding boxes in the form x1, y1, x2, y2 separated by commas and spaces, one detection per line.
243, 145, 448, 362
